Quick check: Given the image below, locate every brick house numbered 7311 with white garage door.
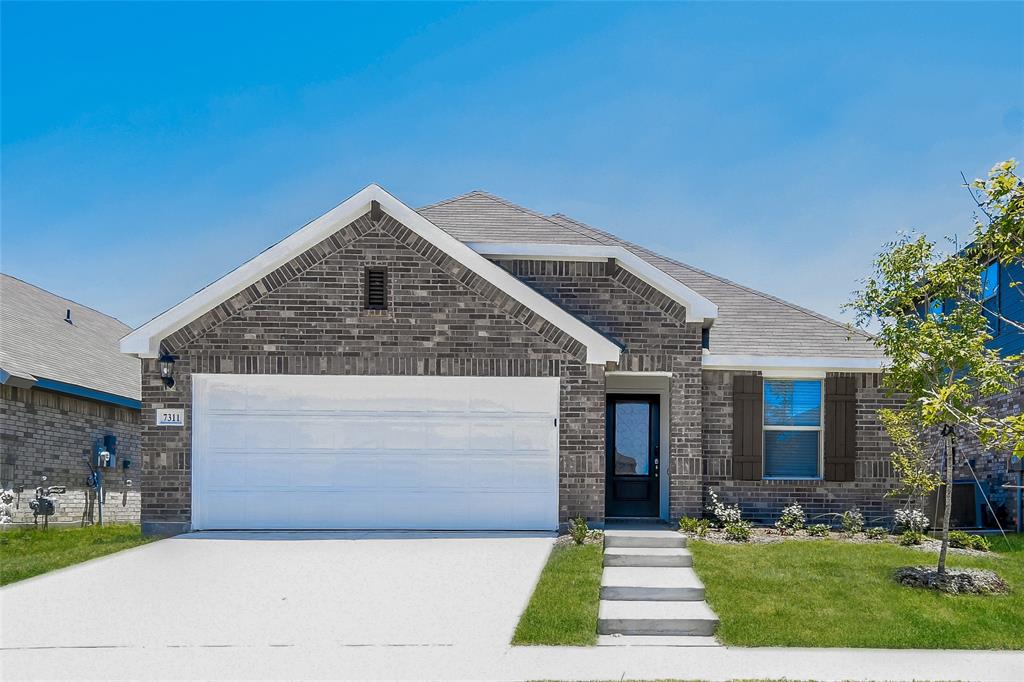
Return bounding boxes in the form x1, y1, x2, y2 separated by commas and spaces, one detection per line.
121, 185, 895, 532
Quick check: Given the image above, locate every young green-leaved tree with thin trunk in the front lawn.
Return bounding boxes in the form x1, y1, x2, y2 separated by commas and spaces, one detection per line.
848, 161, 1024, 576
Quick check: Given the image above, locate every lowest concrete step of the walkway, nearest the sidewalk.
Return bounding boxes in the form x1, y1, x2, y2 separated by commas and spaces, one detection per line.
597, 599, 718, 637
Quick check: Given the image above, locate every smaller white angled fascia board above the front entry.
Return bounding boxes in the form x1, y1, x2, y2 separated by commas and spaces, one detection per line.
468, 242, 718, 327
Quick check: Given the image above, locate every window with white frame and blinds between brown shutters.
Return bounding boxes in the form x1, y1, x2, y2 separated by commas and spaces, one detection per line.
763, 379, 823, 478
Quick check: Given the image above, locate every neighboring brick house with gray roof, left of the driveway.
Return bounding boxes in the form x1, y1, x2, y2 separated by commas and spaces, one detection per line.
0, 274, 141, 523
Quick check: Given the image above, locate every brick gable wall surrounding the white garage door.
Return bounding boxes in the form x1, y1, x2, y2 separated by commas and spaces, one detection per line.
141, 208, 604, 530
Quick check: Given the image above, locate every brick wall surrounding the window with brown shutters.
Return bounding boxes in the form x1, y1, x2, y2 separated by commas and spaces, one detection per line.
702, 371, 899, 525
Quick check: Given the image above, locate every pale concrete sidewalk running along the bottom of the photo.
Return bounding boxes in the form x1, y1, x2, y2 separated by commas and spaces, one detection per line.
0, 638, 1024, 682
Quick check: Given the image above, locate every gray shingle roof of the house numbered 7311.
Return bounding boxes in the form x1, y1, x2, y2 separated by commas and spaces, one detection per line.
420, 191, 882, 358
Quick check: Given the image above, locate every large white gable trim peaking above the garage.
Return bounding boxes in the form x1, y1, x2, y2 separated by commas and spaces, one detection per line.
121, 184, 621, 365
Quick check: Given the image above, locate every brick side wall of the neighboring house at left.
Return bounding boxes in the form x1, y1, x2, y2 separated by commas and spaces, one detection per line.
0, 386, 141, 523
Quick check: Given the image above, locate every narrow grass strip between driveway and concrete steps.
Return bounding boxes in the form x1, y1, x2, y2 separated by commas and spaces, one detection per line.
512, 545, 603, 646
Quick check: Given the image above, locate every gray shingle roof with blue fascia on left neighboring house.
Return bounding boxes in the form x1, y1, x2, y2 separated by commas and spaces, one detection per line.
0, 273, 142, 407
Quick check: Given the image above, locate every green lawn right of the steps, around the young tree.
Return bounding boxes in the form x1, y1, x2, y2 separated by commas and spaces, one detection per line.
690, 535, 1024, 649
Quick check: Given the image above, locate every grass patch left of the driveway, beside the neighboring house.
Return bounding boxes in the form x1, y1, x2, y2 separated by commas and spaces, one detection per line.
0, 525, 155, 585
